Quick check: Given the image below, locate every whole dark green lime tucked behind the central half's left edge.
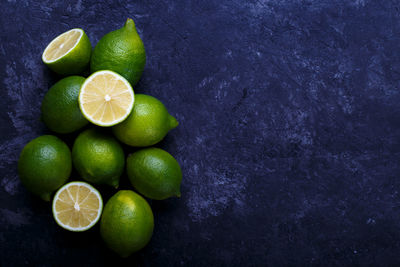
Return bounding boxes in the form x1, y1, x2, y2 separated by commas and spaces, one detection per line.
42, 76, 88, 133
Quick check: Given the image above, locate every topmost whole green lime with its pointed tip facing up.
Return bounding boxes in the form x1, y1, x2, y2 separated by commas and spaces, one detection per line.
90, 18, 146, 85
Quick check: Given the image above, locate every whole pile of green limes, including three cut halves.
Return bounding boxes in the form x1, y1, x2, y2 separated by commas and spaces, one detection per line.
18, 19, 182, 257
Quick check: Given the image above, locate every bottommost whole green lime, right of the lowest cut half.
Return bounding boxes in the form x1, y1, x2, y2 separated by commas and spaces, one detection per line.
100, 190, 154, 257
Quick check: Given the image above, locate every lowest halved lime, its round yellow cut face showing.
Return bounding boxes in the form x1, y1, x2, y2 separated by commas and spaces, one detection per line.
53, 182, 103, 232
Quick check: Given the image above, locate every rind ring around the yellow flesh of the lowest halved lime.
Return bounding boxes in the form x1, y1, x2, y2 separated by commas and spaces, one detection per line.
52, 182, 103, 232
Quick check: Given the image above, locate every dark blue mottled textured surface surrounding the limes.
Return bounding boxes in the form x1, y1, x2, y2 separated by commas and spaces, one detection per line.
0, 0, 400, 266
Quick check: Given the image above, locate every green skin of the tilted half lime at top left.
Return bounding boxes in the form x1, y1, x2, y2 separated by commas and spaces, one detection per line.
45, 32, 92, 76
